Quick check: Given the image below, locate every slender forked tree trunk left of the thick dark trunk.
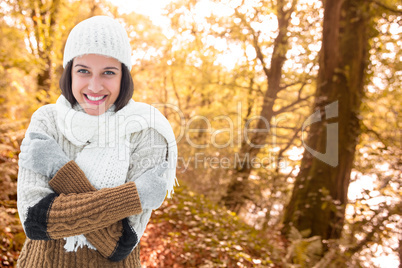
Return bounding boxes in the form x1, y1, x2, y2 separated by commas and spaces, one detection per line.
221, 0, 296, 213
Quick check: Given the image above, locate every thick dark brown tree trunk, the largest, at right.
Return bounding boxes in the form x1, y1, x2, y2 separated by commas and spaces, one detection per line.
282, 0, 370, 243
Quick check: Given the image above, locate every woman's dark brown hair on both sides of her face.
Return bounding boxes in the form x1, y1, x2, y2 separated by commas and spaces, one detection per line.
59, 60, 134, 112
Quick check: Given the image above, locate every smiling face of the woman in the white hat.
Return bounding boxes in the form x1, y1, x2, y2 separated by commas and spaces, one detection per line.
71, 54, 122, 115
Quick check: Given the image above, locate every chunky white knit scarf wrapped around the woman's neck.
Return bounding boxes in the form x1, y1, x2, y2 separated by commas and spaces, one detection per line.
56, 95, 178, 251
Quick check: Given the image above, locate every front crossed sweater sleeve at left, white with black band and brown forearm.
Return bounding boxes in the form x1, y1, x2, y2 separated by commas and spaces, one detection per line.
17, 105, 142, 240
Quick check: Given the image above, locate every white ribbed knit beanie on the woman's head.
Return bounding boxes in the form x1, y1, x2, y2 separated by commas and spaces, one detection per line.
63, 16, 131, 70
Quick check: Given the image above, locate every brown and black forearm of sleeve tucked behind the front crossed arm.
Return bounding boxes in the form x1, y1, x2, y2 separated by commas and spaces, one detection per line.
49, 161, 138, 261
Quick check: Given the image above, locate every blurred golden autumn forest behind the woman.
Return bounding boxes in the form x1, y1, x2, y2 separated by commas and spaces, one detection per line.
0, 0, 402, 267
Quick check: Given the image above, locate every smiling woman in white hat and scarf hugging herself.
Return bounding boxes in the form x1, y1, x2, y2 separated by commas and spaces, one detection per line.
17, 16, 177, 267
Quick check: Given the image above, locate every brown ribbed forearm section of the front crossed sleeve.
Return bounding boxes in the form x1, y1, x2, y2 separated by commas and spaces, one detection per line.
47, 182, 142, 239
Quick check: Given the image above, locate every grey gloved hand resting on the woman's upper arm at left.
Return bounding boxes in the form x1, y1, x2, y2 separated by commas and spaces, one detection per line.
18, 132, 70, 178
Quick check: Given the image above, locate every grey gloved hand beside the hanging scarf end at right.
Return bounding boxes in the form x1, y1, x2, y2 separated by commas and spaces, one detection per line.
135, 162, 168, 209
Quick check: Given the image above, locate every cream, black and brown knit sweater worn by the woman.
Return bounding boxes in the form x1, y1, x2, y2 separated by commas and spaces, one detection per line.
17, 104, 167, 267
